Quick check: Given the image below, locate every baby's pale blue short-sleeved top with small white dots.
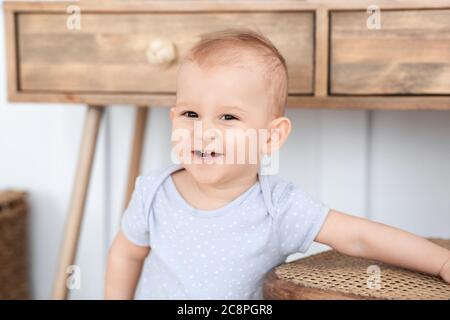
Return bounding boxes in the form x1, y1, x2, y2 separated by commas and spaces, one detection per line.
121, 164, 329, 300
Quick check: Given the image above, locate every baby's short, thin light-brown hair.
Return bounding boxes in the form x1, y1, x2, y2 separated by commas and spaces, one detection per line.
185, 28, 288, 116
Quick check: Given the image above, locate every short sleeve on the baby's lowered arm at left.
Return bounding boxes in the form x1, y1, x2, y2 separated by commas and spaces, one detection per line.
121, 176, 150, 246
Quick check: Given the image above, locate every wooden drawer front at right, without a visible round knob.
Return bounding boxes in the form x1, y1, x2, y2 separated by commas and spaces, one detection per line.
330, 9, 450, 95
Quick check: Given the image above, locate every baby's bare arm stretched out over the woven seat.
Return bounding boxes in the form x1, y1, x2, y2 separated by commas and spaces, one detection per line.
315, 210, 450, 283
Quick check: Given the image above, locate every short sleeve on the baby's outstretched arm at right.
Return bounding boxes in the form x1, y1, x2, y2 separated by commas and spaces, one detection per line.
276, 183, 330, 255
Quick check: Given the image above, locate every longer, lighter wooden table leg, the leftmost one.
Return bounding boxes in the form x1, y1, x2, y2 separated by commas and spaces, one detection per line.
53, 105, 104, 299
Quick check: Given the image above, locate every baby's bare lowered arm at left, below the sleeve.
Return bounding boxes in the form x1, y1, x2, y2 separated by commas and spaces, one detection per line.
105, 232, 150, 300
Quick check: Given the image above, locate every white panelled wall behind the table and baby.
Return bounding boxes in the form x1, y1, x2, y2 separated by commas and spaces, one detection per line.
0, 10, 450, 299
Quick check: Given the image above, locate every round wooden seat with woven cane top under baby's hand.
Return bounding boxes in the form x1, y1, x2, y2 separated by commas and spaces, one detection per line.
264, 238, 450, 300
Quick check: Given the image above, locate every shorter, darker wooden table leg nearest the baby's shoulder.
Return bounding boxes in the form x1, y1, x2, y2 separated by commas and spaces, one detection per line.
125, 106, 149, 209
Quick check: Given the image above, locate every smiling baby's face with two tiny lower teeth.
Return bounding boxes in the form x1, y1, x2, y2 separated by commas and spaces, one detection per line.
170, 62, 274, 184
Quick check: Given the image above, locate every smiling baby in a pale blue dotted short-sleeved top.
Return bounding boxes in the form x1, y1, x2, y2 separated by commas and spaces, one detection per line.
105, 29, 450, 299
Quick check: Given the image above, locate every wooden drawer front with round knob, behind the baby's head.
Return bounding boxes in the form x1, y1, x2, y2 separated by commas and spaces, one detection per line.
17, 12, 314, 95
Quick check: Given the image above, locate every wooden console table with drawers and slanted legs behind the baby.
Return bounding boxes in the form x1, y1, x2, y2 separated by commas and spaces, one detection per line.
4, 0, 450, 299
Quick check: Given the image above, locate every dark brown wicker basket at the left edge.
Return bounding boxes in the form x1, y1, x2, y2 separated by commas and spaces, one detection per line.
0, 190, 29, 300
